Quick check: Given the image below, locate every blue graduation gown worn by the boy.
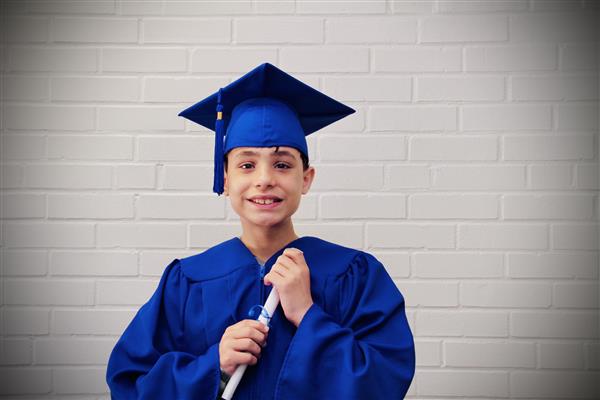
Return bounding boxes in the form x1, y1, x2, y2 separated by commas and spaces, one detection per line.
107, 236, 415, 400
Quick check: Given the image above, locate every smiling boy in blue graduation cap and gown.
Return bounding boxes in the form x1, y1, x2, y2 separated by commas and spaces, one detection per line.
107, 63, 415, 400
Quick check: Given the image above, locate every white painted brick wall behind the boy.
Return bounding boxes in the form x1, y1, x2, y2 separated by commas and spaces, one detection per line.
0, 0, 600, 400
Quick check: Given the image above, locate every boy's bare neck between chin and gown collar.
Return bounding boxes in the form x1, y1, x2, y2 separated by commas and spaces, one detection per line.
240, 221, 298, 262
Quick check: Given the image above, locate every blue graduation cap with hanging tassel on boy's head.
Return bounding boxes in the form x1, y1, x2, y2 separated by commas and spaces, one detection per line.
179, 63, 355, 195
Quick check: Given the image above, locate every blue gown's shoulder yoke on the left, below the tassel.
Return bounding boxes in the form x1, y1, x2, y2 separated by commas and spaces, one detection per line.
179, 237, 255, 281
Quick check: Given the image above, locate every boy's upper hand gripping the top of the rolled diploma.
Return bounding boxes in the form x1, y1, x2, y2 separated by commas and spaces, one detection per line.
264, 248, 313, 327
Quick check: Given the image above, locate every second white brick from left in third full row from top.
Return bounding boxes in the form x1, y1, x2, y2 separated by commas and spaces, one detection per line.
50, 76, 140, 101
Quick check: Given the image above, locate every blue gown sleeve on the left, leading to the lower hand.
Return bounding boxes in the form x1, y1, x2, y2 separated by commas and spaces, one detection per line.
106, 260, 220, 400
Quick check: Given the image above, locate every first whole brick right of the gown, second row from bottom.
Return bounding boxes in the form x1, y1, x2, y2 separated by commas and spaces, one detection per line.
444, 341, 536, 368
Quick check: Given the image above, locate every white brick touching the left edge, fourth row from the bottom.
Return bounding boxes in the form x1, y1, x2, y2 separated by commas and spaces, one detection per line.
4, 279, 94, 306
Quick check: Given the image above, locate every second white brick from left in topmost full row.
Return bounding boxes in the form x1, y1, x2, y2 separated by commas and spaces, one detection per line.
51, 17, 138, 43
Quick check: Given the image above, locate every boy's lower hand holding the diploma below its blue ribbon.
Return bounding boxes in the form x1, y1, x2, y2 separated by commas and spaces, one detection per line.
219, 319, 269, 375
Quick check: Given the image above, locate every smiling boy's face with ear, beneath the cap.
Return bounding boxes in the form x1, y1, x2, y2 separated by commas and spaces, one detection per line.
223, 146, 315, 227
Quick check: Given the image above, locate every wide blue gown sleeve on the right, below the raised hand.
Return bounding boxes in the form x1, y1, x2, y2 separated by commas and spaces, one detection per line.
275, 252, 415, 400
